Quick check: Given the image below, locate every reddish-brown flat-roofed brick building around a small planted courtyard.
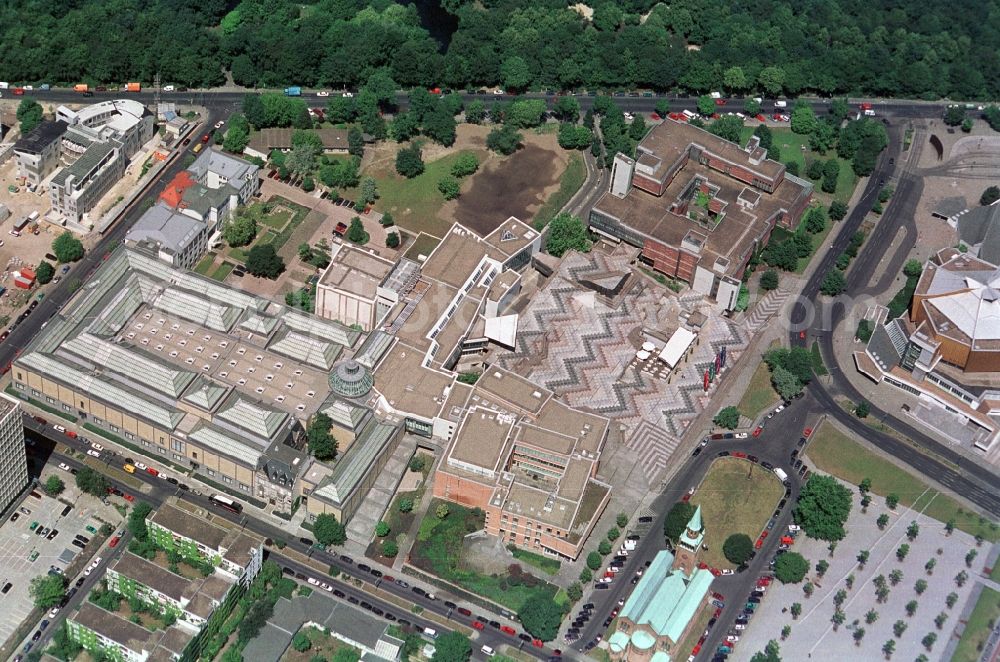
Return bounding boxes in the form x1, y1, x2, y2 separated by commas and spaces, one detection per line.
588, 120, 812, 309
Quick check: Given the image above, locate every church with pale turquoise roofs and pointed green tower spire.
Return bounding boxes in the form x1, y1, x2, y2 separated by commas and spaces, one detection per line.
608, 506, 715, 662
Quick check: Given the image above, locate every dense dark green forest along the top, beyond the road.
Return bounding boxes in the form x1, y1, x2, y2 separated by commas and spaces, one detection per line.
0, 0, 1000, 99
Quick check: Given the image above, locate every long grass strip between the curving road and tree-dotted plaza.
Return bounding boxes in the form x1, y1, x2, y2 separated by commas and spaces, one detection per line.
806, 424, 1000, 542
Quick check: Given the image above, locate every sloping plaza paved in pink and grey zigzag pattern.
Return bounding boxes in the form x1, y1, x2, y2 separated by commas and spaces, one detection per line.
494, 252, 752, 483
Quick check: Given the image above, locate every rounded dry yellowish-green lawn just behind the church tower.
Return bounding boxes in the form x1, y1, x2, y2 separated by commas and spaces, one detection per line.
691, 457, 785, 568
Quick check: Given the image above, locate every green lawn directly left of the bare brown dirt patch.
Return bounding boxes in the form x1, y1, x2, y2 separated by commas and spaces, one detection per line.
376, 150, 478, 236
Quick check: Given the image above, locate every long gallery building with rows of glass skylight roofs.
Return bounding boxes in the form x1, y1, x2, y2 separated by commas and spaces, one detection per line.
11, 248, 360, 512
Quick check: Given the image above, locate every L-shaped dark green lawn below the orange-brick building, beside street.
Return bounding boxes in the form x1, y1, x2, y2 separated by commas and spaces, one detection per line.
410, 499, 558, 611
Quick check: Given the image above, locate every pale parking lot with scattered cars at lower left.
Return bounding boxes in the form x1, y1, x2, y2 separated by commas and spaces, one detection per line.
0, 464, 122, 641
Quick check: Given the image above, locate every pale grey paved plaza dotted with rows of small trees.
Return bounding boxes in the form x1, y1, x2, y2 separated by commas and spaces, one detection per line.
728, 478, 989, 660
